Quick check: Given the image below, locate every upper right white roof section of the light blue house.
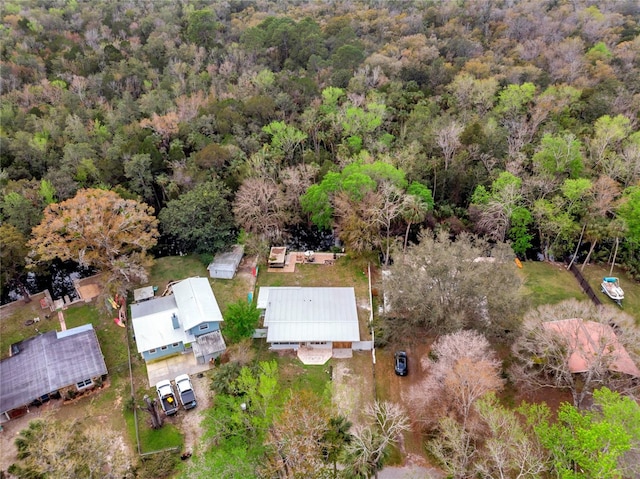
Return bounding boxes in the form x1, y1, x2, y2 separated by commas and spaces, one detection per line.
173, 278, 223, 329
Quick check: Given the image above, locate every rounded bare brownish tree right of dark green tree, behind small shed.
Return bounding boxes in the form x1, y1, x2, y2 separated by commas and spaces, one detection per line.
233, 178, 289, 241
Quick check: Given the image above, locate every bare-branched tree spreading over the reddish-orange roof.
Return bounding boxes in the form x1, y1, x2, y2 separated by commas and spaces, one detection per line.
509, 299, 640, 407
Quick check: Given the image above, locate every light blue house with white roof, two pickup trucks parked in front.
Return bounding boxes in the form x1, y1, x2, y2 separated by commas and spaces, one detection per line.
131, 278, 226, 364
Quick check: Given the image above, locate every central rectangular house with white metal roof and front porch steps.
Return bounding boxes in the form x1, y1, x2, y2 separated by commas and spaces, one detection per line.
257, 287, 370, 360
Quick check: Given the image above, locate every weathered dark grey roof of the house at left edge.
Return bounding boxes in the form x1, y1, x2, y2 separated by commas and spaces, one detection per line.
0, 324, 107, 412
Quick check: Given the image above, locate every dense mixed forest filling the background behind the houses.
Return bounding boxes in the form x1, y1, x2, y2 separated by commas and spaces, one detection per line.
0, 0, 640, 294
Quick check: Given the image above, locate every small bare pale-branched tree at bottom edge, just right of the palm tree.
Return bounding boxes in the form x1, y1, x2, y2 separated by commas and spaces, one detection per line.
345, 401, 410, 478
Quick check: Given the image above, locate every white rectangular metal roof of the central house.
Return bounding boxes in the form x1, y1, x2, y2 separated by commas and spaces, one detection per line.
260, 287, 360, 343
